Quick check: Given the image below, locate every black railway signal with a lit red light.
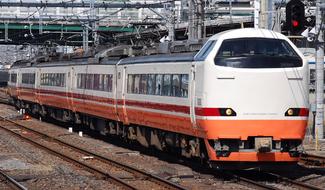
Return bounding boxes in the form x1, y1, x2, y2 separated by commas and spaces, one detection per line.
286, 0, 305, 35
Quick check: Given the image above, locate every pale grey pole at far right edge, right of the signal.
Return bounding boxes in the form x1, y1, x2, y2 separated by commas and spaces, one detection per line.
315, 0, 325, 141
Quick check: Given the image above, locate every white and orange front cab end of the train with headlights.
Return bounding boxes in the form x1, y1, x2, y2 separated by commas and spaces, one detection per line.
195, 29, 309, 166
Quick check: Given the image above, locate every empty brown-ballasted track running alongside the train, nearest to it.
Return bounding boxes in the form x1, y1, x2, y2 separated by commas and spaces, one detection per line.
0, 116, 186, 190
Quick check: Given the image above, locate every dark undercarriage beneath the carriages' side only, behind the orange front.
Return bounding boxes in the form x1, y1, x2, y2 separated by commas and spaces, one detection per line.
12, 99, 208, 162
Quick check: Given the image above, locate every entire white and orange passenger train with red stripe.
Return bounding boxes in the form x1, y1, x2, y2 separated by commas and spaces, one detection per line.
9, 29, 309, 169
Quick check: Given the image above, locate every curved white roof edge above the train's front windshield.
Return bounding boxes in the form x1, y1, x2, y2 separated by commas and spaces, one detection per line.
209, 28, 286, 40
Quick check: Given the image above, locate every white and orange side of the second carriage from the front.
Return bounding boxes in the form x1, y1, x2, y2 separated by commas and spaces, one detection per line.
71, 65, 117, 120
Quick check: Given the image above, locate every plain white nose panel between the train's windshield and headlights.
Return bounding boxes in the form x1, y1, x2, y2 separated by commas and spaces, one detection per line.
208, 68, 308, 119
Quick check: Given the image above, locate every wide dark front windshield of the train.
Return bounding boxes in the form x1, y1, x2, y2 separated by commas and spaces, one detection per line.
215, 38, 302, 68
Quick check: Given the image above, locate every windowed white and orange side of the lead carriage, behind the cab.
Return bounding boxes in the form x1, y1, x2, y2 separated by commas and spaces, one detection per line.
117, 62, 204, 137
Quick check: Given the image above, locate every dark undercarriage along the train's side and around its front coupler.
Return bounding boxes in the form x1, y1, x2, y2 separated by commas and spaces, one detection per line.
12, 99, 301, 170
